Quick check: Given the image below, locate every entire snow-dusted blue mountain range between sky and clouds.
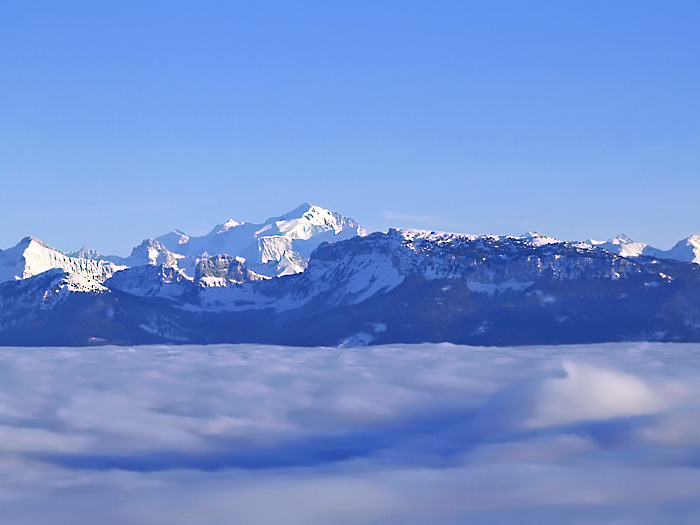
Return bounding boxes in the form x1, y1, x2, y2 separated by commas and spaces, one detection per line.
0, 204, 700, 346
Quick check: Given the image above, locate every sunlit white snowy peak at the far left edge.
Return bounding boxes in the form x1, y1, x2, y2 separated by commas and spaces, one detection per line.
0, 237, 117, 288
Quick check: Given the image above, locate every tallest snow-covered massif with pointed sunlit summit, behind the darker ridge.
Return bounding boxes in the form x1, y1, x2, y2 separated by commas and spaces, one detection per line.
156, 204, 367, 277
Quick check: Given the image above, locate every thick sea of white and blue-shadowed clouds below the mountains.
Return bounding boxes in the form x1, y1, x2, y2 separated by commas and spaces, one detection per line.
0, 343, 700, 525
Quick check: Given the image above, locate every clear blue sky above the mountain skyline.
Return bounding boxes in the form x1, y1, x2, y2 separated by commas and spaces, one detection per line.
0, 0, 700, 254
